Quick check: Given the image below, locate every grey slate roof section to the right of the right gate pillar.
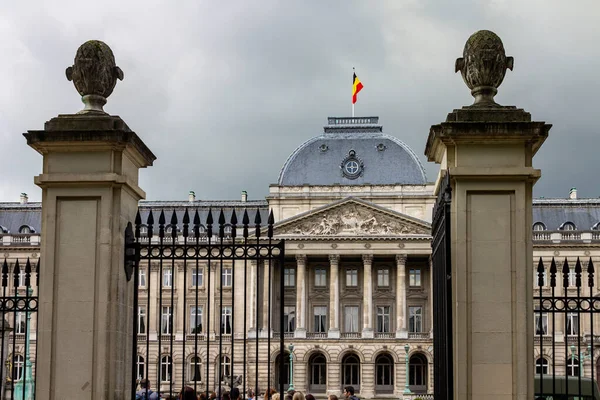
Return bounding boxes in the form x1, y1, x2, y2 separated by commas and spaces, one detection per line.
533, 199, 600, 231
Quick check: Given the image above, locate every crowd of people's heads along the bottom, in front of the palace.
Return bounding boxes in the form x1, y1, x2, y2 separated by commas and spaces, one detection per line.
135, 379, 358, 400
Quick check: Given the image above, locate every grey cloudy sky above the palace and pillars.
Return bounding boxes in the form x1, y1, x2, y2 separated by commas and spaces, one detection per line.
0, 0, 600, 201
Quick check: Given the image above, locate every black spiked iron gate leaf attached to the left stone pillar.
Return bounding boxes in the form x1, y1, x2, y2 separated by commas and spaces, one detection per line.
126, 209, 287, 398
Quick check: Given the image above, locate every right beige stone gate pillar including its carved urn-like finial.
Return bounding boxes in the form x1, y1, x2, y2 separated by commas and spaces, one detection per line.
425, 31, 551, 400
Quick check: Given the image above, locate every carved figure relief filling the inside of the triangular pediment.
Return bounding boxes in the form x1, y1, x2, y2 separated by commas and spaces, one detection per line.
277, 204, 430, 236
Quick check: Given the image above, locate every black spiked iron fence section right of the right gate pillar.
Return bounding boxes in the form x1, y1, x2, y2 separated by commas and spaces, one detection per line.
534, 257, 600, 399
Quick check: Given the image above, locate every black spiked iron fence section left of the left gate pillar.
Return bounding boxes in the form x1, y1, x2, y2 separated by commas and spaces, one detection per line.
0, 258, 40, 400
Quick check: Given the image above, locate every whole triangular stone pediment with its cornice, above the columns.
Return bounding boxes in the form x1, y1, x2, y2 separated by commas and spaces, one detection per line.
274, 197, 431, 237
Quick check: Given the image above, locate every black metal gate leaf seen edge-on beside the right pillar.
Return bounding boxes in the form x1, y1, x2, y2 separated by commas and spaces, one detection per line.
432, 174, 453, 400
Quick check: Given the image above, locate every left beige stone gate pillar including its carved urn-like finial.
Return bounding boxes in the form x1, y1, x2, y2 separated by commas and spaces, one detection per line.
24, 41, 156, 400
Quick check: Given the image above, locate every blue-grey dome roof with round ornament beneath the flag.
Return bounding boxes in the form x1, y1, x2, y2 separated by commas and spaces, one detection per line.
278, 117, 427, 186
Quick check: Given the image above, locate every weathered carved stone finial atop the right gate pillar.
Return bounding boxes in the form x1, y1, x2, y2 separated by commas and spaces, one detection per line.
455, 30, 514, 107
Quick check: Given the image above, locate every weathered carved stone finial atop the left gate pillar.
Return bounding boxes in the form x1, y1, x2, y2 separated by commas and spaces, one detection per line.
66, 40, 123, 114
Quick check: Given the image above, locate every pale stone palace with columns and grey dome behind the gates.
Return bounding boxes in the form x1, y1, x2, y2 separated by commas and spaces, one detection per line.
0, 117, 600, 398
